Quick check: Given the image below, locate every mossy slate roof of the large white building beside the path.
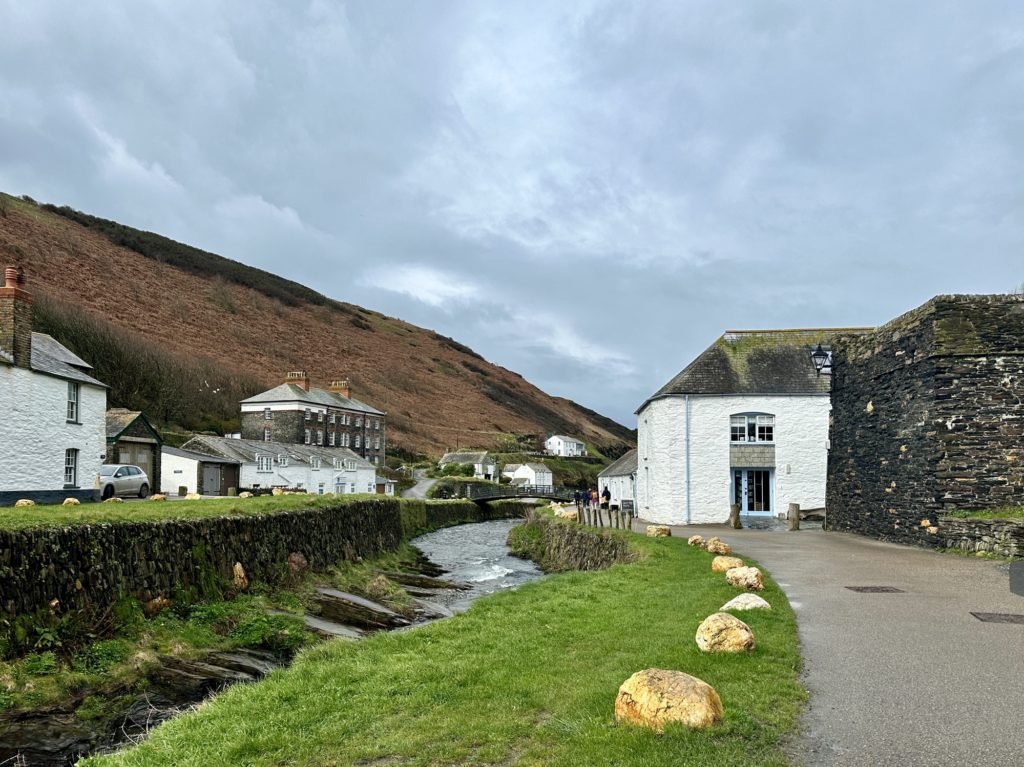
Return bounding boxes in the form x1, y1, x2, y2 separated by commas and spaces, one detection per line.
637, 328, 873, 413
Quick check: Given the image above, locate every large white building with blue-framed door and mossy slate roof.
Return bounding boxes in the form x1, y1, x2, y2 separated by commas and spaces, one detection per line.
636, 329, 863, 524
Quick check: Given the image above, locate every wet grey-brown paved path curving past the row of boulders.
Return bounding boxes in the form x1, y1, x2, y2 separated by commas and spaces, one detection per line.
634, 525, 1024, 767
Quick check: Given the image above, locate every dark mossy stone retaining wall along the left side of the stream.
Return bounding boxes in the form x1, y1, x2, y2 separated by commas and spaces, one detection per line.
0, 499, 517, 619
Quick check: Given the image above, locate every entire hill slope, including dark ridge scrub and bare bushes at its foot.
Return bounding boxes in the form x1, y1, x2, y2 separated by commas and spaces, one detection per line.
0, 196, 633, 455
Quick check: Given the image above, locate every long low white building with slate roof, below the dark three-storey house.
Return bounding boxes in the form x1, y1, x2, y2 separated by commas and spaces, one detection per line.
182, 434, 377, 495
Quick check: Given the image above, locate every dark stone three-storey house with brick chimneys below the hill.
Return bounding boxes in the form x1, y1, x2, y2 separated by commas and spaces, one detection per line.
242, 371, 386, 466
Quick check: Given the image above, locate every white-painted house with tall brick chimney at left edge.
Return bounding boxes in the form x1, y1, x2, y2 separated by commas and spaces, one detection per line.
0, 267, 106, 504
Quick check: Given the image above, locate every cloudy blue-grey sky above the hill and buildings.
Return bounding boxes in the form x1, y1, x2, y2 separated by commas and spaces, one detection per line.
0, 0, 1024, 426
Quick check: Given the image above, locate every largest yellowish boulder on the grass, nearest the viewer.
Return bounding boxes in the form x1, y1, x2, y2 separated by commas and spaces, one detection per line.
615, 669, 724, 732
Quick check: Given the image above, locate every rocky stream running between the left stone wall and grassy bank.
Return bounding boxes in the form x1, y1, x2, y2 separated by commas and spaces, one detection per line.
0, 519, 544, 767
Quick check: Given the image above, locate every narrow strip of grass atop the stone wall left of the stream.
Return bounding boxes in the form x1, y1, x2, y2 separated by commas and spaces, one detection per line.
0, 494, 417, 529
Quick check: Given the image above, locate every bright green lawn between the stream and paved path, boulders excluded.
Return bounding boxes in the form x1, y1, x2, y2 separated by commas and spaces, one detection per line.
82, 534, 805, 767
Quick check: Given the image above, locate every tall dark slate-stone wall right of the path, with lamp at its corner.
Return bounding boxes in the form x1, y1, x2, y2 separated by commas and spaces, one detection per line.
826, 296, 1024, 547
